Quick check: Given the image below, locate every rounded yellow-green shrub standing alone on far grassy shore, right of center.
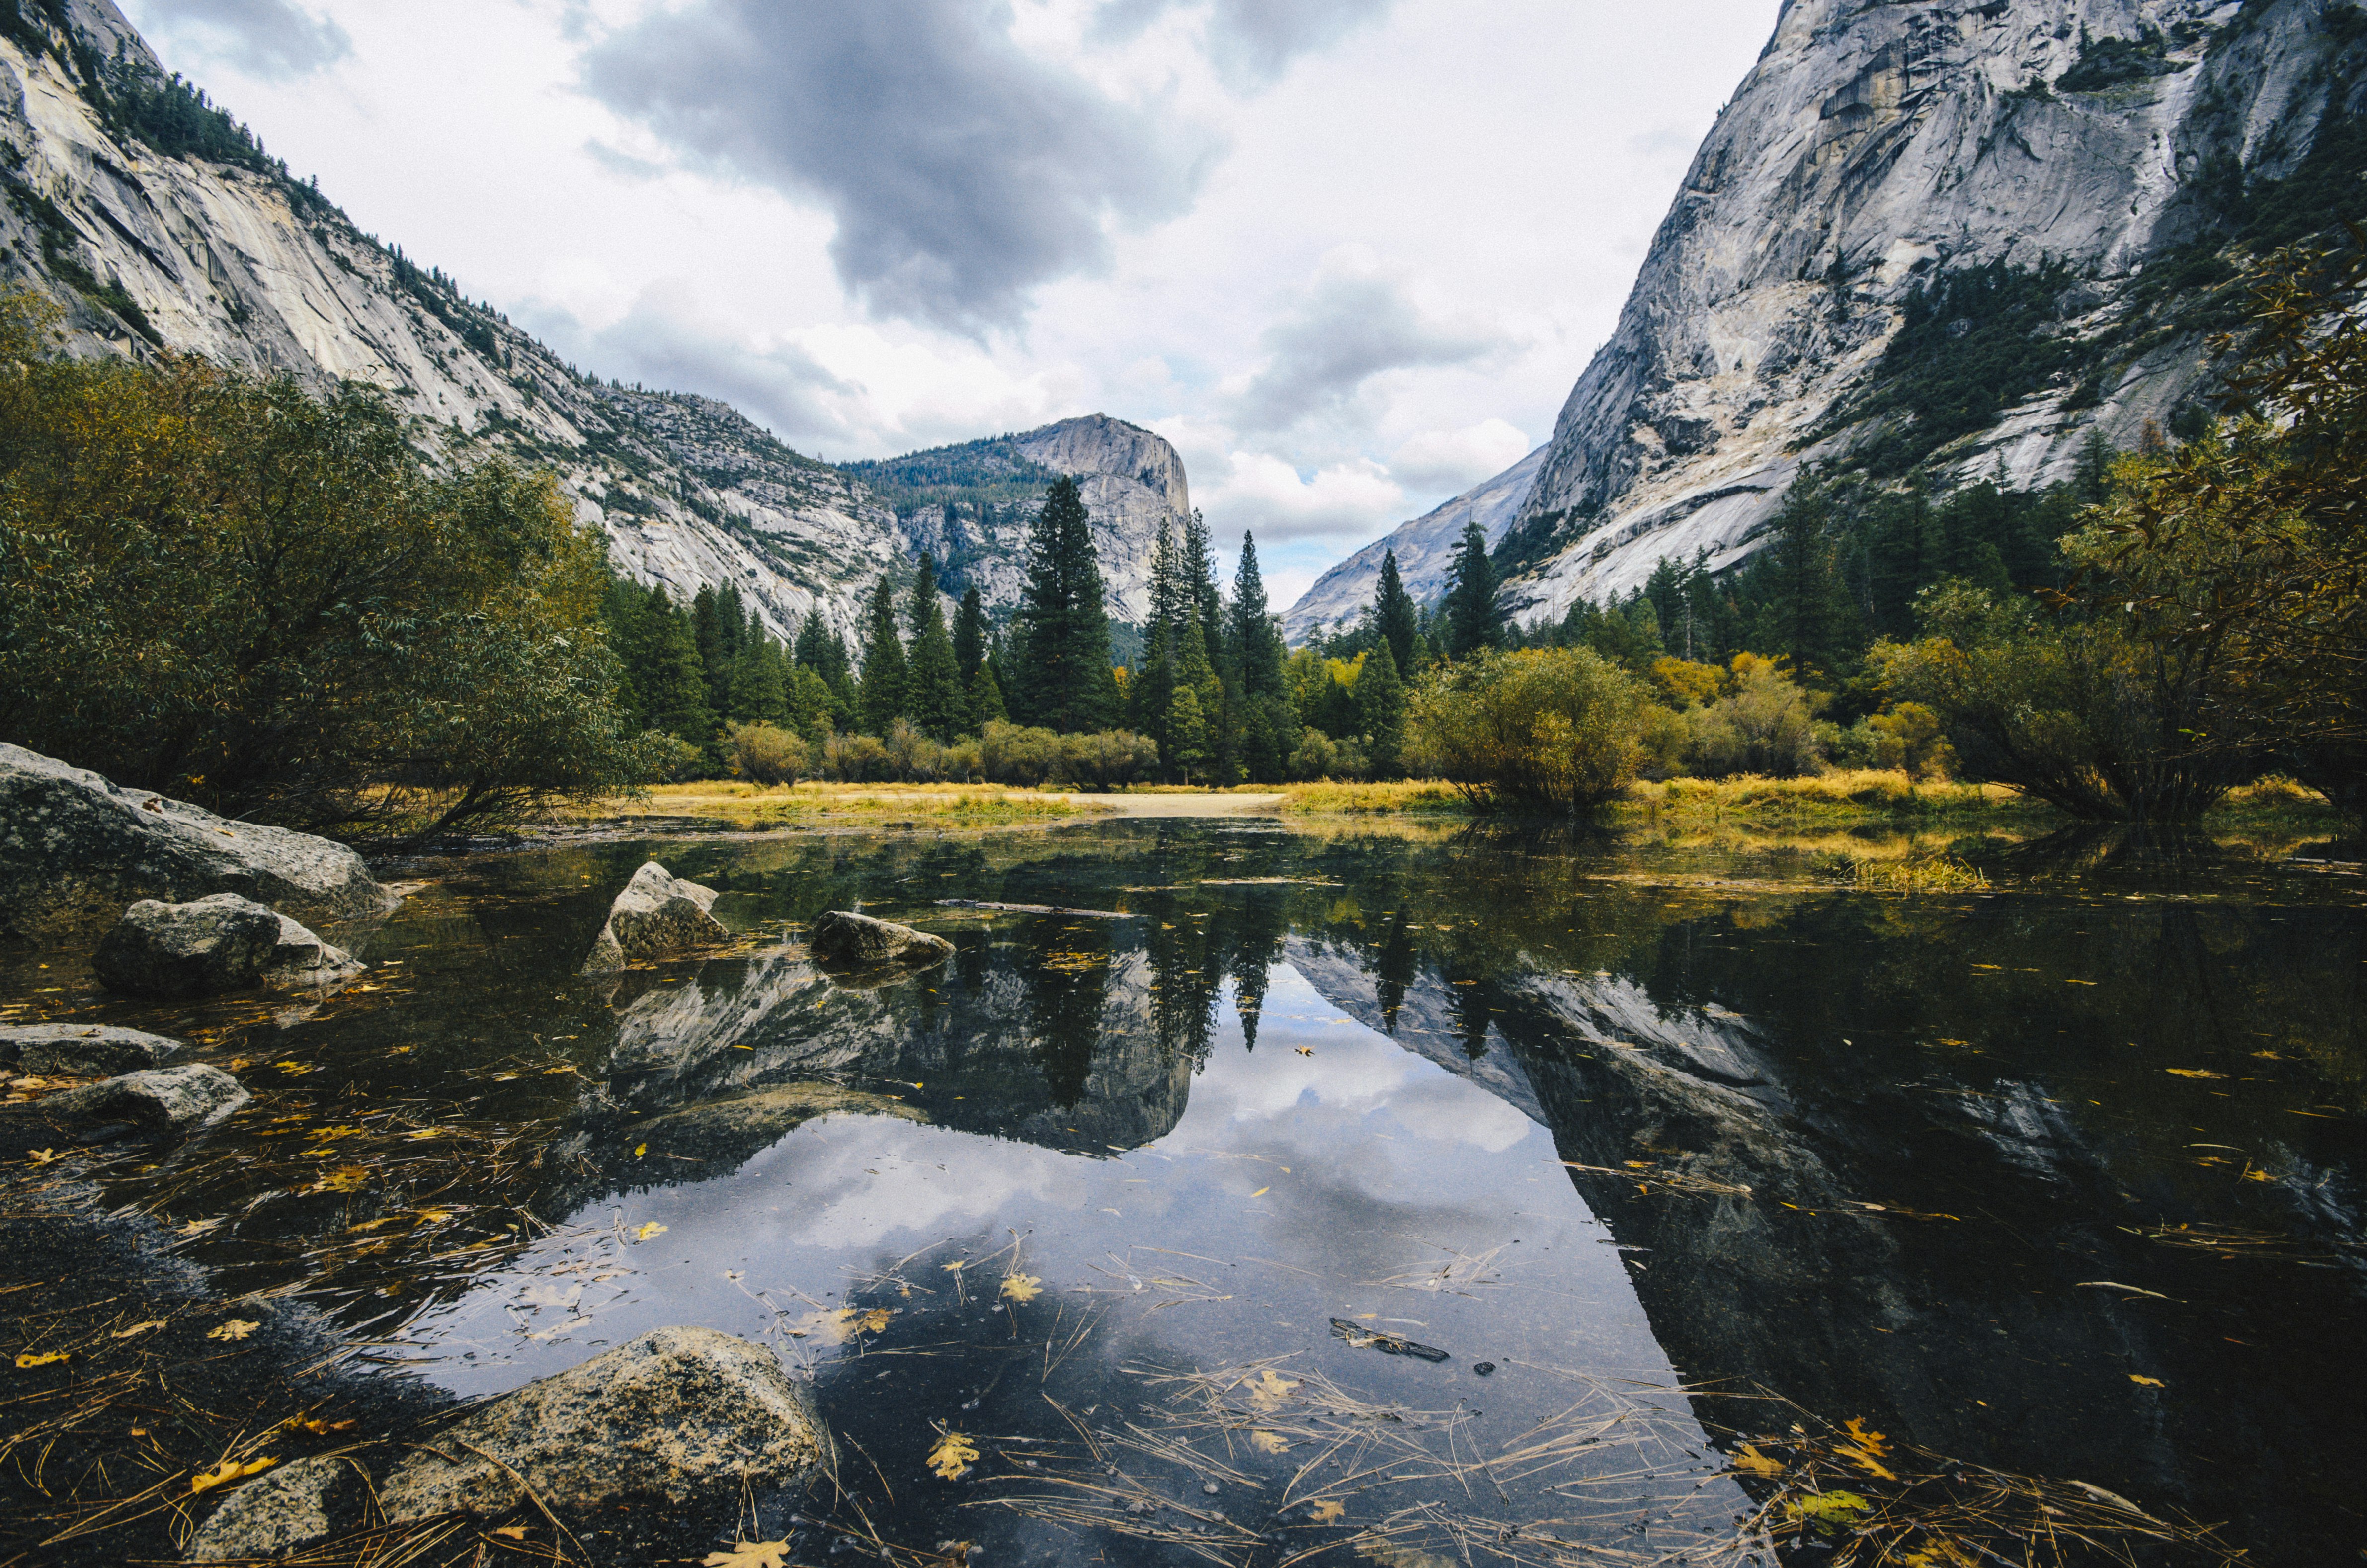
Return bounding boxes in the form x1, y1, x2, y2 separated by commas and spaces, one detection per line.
1408, 649, 1650, 813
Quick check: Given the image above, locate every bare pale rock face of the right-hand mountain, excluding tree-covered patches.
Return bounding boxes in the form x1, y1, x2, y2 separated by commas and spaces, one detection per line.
1508, 0, 2367, 621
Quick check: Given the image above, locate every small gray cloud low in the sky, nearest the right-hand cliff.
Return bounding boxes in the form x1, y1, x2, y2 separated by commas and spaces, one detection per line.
1235, 272, 1498, 433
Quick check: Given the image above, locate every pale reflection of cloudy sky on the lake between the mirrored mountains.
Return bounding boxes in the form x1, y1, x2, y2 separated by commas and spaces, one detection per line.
409, 966, 1671, 1404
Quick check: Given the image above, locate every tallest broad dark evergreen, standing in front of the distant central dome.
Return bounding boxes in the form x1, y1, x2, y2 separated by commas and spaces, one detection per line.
1004, 479, 1117, 732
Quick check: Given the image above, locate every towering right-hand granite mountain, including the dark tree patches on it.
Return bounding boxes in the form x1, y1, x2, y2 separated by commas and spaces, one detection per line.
1498, 0, 2367, 621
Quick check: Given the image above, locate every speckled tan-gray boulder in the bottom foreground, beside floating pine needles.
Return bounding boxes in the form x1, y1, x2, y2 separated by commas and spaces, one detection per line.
379, 1326, 835, 1525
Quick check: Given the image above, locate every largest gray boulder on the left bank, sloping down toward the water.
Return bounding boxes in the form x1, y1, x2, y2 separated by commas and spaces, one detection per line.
0, 743, 398, 936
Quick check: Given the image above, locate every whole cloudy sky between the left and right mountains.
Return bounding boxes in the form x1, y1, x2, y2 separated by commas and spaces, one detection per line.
121, 0, 1778, 604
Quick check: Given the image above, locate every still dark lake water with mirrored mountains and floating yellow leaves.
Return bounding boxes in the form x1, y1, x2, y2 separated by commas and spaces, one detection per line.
9, 822, 2367, 1563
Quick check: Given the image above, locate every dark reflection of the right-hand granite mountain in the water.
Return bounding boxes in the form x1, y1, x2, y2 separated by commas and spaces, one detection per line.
1288, 895, 2360, 1561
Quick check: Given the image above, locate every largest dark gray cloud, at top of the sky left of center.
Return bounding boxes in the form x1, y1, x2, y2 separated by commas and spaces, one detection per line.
584, 0, 1207, 334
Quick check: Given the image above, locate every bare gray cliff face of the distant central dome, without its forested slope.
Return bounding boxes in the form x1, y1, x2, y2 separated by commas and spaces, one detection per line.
897, 414, 1193, 625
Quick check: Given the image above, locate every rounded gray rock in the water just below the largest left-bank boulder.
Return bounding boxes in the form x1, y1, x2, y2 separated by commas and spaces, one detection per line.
90, 893, 362, 999
